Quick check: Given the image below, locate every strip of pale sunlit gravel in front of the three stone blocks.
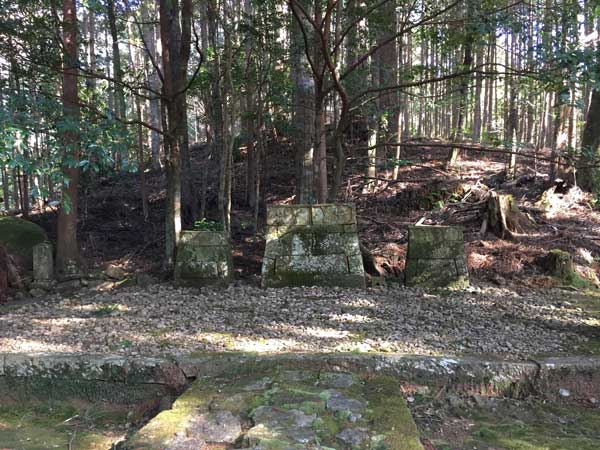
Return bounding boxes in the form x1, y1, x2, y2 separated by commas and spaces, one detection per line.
0, 284, 600, 358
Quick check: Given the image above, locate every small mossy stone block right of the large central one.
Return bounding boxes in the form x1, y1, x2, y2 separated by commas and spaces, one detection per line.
405, 225, 469, 289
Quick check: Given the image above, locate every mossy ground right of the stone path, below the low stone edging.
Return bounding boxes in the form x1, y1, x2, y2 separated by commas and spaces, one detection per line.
409, 390, 600, 450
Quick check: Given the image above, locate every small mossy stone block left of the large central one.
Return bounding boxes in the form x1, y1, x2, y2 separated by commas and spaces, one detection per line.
175, 231, 233, 286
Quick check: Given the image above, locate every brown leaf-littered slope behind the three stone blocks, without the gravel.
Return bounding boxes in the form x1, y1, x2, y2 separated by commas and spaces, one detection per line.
25, 139, 600, 287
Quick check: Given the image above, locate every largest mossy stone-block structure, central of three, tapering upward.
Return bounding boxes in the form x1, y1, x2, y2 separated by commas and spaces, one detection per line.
262, 204, 365, 288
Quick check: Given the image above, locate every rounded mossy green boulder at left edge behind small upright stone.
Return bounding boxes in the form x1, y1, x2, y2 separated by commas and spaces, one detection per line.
0, 216, 48, 269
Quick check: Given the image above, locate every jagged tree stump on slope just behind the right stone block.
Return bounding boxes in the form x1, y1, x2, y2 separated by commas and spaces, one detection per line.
481, 192, 535, 239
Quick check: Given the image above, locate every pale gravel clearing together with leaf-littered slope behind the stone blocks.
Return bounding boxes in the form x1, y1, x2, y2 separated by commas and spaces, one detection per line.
0, 141, 600, 358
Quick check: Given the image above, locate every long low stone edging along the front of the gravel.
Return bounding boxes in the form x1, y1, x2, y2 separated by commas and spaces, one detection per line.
0, 353, 600, 402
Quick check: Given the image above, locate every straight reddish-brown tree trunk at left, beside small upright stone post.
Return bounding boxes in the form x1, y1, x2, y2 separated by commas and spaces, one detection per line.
56, 0, 80, 277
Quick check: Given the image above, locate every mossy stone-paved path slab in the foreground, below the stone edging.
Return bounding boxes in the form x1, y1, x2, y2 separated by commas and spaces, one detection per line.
123, 368, 423, 450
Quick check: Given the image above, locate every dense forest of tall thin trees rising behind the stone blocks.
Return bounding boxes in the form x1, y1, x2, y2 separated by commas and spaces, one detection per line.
0, 0, 600, 282
